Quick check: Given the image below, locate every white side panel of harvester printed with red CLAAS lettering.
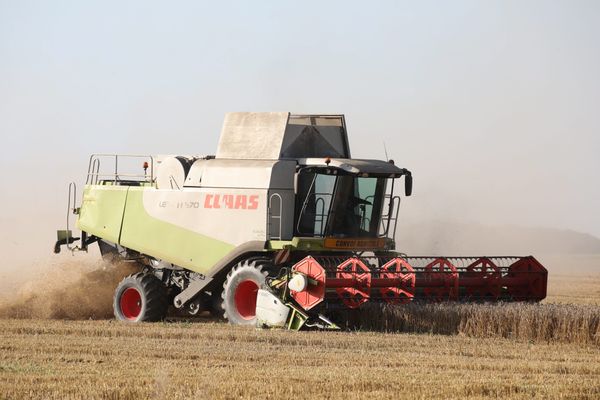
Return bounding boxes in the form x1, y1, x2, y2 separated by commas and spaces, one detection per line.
175, 159, 297, 241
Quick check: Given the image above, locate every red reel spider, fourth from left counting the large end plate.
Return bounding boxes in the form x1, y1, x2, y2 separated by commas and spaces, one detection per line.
423, 258, 458, 301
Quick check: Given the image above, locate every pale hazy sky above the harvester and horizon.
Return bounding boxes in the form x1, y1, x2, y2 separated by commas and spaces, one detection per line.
0, 0, 600, 260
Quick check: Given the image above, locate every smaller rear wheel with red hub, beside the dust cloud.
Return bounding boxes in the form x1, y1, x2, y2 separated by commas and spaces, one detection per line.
113, 272, 169, 322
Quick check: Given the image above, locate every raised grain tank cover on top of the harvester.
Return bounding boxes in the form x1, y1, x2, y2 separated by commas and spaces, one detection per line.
216, 112, 350, 160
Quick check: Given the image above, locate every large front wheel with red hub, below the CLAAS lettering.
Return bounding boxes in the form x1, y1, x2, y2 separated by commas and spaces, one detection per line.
221, 260, 267, 325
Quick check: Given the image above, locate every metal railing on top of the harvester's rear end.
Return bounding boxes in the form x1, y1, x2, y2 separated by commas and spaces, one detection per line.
85, 154, 155, 185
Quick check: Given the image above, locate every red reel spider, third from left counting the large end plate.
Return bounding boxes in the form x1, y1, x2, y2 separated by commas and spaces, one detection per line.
379, 258, 416, 304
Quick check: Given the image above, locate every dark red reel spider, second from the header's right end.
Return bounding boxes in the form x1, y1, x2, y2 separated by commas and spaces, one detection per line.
464, 257, 502, 300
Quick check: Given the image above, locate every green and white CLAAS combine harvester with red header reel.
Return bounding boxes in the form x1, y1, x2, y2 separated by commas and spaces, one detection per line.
55, 112, 547, 329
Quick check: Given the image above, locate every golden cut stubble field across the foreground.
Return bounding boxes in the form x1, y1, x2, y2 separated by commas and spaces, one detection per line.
0, 320, 600, 399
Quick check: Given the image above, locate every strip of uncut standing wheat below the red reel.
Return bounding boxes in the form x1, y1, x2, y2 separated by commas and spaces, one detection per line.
355, 303, 600, 345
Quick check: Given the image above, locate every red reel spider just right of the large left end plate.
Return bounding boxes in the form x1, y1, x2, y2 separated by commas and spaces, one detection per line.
335, 258, 371, 308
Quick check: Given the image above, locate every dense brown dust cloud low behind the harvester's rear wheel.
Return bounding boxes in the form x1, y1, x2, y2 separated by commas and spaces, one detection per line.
0, 258, 136, 319
